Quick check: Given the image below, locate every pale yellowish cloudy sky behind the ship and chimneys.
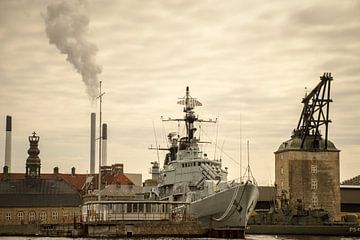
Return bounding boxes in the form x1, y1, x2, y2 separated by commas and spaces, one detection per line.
0, 0, 360, 184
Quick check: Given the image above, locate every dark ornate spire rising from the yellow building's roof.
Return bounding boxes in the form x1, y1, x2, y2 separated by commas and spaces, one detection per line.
26, 132, 41, 179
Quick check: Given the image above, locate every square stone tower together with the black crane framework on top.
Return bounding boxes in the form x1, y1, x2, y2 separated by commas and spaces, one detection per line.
275, 73, 340, 220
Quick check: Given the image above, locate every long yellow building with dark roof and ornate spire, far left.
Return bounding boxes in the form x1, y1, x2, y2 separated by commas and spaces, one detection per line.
0, 132, 81, 227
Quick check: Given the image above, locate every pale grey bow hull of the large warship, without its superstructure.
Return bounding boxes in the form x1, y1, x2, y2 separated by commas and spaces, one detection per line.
190, 181, 259, 230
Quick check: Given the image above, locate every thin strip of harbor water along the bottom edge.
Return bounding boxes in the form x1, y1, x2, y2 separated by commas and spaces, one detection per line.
0, 234, 359, 240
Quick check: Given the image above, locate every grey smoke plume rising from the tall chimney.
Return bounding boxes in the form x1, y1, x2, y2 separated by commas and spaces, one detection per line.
43, 1, 101, 101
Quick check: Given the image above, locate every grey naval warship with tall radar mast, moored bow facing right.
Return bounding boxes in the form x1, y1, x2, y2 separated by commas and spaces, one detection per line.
149, 87, 259, 233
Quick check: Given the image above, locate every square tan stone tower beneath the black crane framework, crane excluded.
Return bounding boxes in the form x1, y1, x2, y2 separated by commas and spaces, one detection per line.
275, 136, 340, 220
